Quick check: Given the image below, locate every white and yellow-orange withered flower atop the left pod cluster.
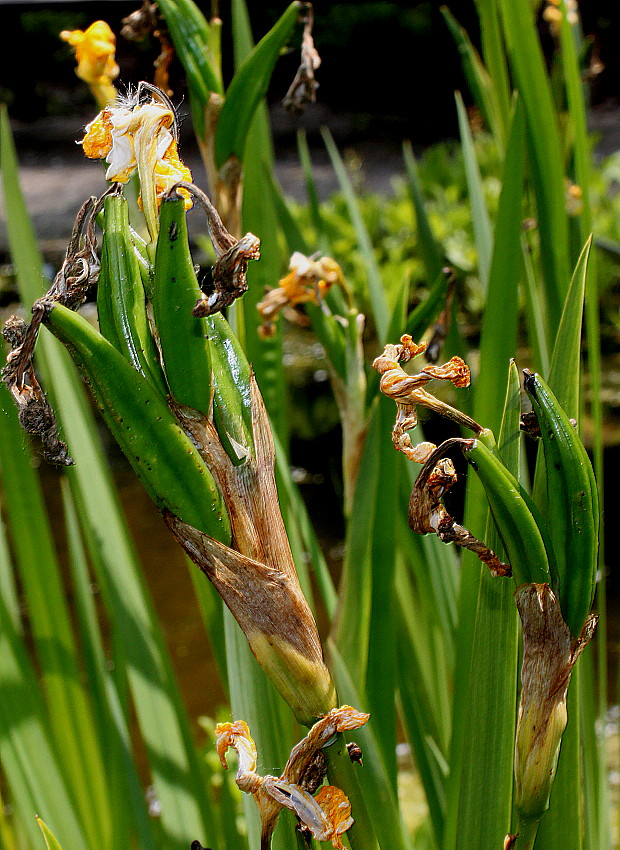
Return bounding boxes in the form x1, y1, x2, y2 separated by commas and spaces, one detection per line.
82, 84, 192, 240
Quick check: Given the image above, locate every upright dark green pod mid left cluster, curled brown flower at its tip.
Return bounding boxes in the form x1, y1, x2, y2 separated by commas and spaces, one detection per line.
152, 192, 216, 415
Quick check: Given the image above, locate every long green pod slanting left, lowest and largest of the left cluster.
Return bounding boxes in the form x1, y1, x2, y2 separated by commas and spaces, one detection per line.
44, 304, 230, 544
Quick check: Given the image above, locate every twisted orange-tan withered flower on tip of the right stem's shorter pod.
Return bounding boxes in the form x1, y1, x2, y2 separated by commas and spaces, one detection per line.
372, 334, 484, 463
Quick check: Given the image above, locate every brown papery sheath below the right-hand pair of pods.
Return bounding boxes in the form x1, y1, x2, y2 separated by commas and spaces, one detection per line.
515, 584, 597, 822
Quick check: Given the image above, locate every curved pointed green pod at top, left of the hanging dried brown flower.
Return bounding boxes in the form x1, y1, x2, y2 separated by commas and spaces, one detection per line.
215, 2, 301, 168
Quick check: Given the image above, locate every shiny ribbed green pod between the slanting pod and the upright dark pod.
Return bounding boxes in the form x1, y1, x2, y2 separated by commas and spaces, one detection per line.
97, 195, 166, 395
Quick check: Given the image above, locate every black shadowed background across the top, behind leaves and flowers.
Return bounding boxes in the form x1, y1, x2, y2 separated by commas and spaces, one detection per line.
0, 0, 620, 144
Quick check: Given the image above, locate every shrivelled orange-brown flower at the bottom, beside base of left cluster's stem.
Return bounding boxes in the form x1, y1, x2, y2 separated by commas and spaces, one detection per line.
215, 705, 370, 850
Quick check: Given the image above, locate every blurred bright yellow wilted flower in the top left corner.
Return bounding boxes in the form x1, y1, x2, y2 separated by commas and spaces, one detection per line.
60, 21, 119, 107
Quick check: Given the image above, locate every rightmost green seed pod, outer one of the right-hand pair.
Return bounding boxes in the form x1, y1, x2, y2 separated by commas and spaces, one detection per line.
525, 371, 599, 637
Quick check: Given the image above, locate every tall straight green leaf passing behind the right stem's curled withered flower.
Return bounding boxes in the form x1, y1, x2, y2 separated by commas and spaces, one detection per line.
444, 103, 524, 850
